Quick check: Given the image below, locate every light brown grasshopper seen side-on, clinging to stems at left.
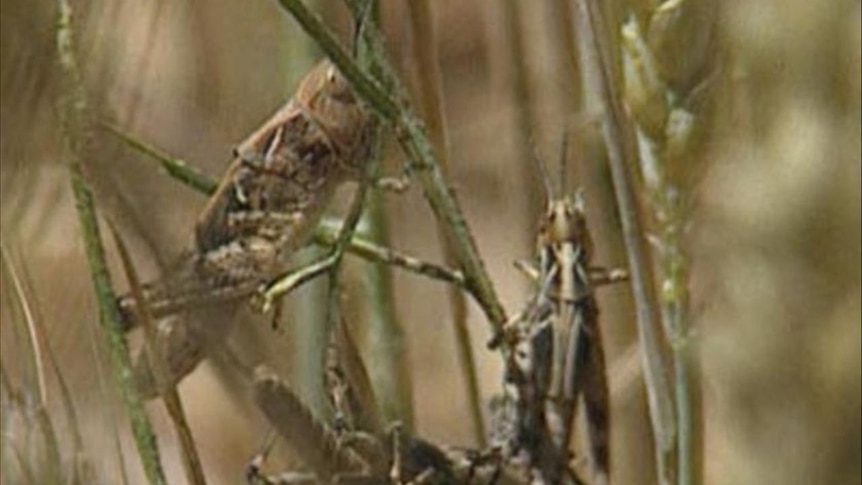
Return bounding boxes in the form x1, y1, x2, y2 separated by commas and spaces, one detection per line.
118, 60, 376, 394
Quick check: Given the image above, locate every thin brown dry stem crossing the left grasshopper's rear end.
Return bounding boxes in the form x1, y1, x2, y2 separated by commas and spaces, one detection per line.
108, 224, 206, 485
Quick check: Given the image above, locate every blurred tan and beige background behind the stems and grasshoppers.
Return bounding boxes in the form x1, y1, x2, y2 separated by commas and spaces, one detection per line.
0, 0, 862, 484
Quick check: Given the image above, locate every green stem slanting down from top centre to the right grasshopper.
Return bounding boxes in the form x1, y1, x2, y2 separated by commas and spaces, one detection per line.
279, 0, 506, 335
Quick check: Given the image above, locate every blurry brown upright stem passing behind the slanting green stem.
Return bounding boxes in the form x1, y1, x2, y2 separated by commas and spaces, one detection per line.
408, 0, 487, 447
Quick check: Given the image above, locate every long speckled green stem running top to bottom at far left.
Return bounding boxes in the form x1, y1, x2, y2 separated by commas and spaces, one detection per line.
57, 0, 166, 485
